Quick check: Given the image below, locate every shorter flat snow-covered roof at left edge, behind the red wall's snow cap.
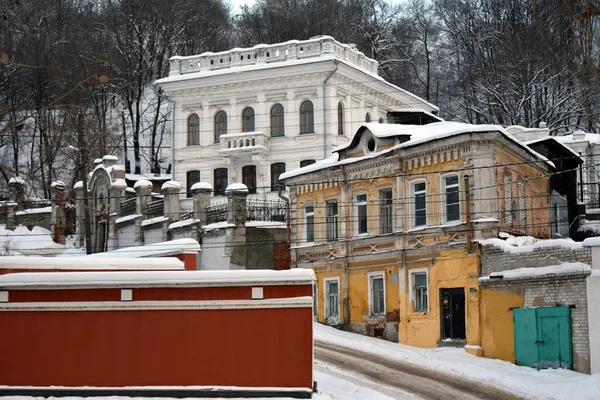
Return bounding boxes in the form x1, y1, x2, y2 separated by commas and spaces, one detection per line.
0, 253, 184, 275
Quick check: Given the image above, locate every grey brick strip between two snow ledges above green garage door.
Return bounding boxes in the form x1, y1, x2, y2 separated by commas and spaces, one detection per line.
480, 244, 592, 276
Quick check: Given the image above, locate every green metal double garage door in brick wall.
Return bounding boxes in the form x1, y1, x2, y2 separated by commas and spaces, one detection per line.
513, 306, 573, 369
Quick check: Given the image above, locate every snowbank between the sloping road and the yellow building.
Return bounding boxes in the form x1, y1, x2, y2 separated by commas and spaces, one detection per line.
314, 324, 600, 400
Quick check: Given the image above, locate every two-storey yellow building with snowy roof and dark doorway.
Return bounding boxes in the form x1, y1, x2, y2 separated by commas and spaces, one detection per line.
281, 116, 553, 353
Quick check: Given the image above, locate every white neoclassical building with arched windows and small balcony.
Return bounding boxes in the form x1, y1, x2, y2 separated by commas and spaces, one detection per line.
158, 36, 438, 203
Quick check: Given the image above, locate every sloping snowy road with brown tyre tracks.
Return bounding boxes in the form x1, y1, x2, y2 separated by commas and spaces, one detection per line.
315, 341, 517, 400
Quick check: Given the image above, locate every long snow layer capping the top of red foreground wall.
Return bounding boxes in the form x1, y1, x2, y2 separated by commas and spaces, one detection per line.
0, 268, 315, 290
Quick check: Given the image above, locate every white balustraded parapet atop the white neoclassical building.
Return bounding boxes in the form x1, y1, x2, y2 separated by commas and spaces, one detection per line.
169, 36, 379, 76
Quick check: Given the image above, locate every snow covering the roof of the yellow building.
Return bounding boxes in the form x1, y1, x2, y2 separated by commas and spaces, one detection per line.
279, 121, 554, 180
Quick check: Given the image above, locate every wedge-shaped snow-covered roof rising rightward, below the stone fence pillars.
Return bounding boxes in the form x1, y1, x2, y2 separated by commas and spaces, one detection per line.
86, 238, 200, 258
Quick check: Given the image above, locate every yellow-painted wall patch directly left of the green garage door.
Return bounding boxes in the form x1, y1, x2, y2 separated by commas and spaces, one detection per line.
481, 288, 524, 362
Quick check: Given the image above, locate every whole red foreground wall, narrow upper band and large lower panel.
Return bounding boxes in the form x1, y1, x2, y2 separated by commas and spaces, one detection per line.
0, 280, 313, 389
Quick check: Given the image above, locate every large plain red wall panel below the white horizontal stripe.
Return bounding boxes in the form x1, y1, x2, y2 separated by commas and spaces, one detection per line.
0, 308, 313, 388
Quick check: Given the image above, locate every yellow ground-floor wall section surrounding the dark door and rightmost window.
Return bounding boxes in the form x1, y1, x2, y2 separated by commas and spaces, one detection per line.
399, 248, 479, 347
